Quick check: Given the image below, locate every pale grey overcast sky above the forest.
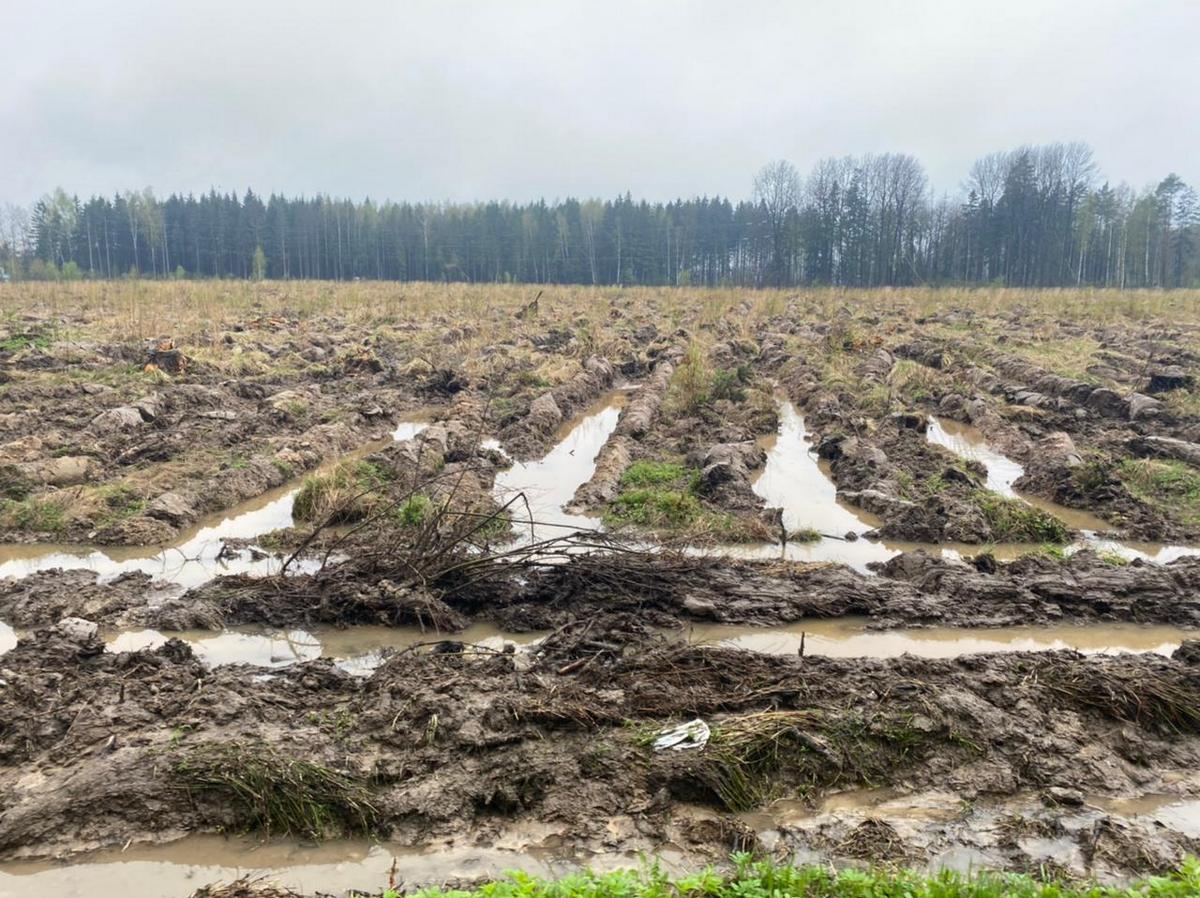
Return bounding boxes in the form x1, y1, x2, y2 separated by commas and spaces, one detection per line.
0, 0, 1200, 204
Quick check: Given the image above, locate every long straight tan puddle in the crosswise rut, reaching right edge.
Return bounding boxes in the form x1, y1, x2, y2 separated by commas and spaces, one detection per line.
689, 617, 1193, 658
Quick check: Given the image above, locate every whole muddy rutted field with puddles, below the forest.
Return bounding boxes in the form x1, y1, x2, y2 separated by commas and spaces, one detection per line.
0, 283, 1200, 897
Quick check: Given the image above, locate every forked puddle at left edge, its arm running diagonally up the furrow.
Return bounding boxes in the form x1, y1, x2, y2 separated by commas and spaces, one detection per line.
0, 414, 428, 587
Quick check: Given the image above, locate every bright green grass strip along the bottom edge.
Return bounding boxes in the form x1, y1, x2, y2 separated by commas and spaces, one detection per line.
360, 855, 1200, 898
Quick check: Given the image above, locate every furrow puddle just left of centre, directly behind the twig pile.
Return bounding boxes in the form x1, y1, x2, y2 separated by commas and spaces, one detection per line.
493, 390, 629, 544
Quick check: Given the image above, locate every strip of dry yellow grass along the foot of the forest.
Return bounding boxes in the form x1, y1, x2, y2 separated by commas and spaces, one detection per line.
0, 280, 1200, 336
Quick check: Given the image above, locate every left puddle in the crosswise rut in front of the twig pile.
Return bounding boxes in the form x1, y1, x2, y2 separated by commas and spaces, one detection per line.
107, 623, 546, 676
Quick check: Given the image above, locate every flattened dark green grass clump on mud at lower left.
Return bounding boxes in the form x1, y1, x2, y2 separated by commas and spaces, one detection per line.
173, 742, 378, 839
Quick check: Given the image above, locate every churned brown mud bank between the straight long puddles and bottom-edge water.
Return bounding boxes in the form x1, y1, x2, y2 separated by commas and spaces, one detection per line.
0, 631, 1200, 878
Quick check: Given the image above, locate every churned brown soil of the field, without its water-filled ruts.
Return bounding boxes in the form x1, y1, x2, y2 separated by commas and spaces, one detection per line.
7, 291, 1200, 878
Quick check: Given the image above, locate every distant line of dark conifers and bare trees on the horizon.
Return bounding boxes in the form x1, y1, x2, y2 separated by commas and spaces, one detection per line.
0, 143, 1200, 288
